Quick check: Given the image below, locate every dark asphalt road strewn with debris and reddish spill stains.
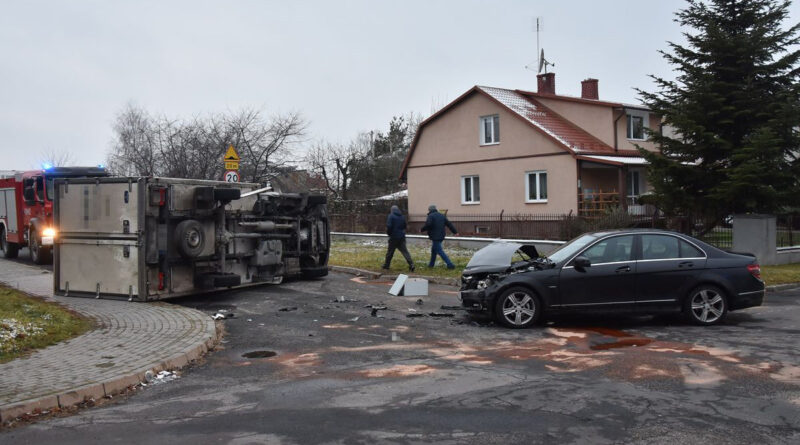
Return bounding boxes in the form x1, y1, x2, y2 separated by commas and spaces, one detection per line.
0, 268, 800, 444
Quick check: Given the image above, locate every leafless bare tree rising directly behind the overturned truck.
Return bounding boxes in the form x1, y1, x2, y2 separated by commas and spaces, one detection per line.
108, 104, 306, 182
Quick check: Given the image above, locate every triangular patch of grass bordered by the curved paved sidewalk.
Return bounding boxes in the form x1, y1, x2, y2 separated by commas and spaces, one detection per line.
0, 286, 92, 363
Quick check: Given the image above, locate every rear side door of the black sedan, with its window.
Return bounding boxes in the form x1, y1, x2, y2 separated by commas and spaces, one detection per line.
636, 233, 706, 310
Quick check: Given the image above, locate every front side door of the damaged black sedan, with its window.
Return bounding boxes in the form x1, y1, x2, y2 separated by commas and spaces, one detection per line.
558, 235, 636, 308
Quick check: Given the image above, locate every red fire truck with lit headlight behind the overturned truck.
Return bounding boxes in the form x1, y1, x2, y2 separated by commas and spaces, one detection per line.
0, 167, 108, 264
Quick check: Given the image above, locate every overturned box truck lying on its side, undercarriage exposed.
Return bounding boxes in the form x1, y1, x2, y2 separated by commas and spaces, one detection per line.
53, 177, 330, 301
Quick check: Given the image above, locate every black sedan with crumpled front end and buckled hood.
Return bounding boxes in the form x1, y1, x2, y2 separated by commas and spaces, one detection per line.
459, 229, 765, 328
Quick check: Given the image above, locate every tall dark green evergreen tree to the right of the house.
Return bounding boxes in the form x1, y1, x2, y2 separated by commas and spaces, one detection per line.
639, 0, 800, 233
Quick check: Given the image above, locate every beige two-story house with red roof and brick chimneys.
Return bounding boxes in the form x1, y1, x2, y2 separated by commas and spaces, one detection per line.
401, 73, 661, 215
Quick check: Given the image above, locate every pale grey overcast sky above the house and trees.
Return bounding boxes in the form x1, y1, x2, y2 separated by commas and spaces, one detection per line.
0, 0, 798, 170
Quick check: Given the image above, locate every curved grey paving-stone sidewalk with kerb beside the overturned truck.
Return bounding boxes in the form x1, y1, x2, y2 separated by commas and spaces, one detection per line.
0, 260, 217, 423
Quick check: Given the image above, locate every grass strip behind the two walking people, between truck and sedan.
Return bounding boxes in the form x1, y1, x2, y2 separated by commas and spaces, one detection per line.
329, 240, 475, 278
